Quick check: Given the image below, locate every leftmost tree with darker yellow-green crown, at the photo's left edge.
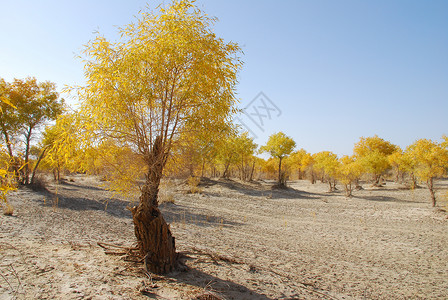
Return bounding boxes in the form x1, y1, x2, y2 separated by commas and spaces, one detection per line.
0, 77, 64, 184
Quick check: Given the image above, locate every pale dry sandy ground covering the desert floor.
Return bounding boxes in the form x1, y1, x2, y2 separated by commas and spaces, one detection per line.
0, 175, 448, 299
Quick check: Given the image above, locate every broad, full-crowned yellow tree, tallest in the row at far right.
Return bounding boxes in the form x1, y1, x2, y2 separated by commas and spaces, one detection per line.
353, 135, 397, 186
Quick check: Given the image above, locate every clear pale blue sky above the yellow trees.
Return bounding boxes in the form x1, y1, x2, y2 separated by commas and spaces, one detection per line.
0, 0, 448, 155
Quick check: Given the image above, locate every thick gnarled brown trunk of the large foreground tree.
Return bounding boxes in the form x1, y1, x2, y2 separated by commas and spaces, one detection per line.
131, 136, 177, 274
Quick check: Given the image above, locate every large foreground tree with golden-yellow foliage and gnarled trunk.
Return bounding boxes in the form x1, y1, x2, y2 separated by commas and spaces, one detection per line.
78, 0, 241, 273
